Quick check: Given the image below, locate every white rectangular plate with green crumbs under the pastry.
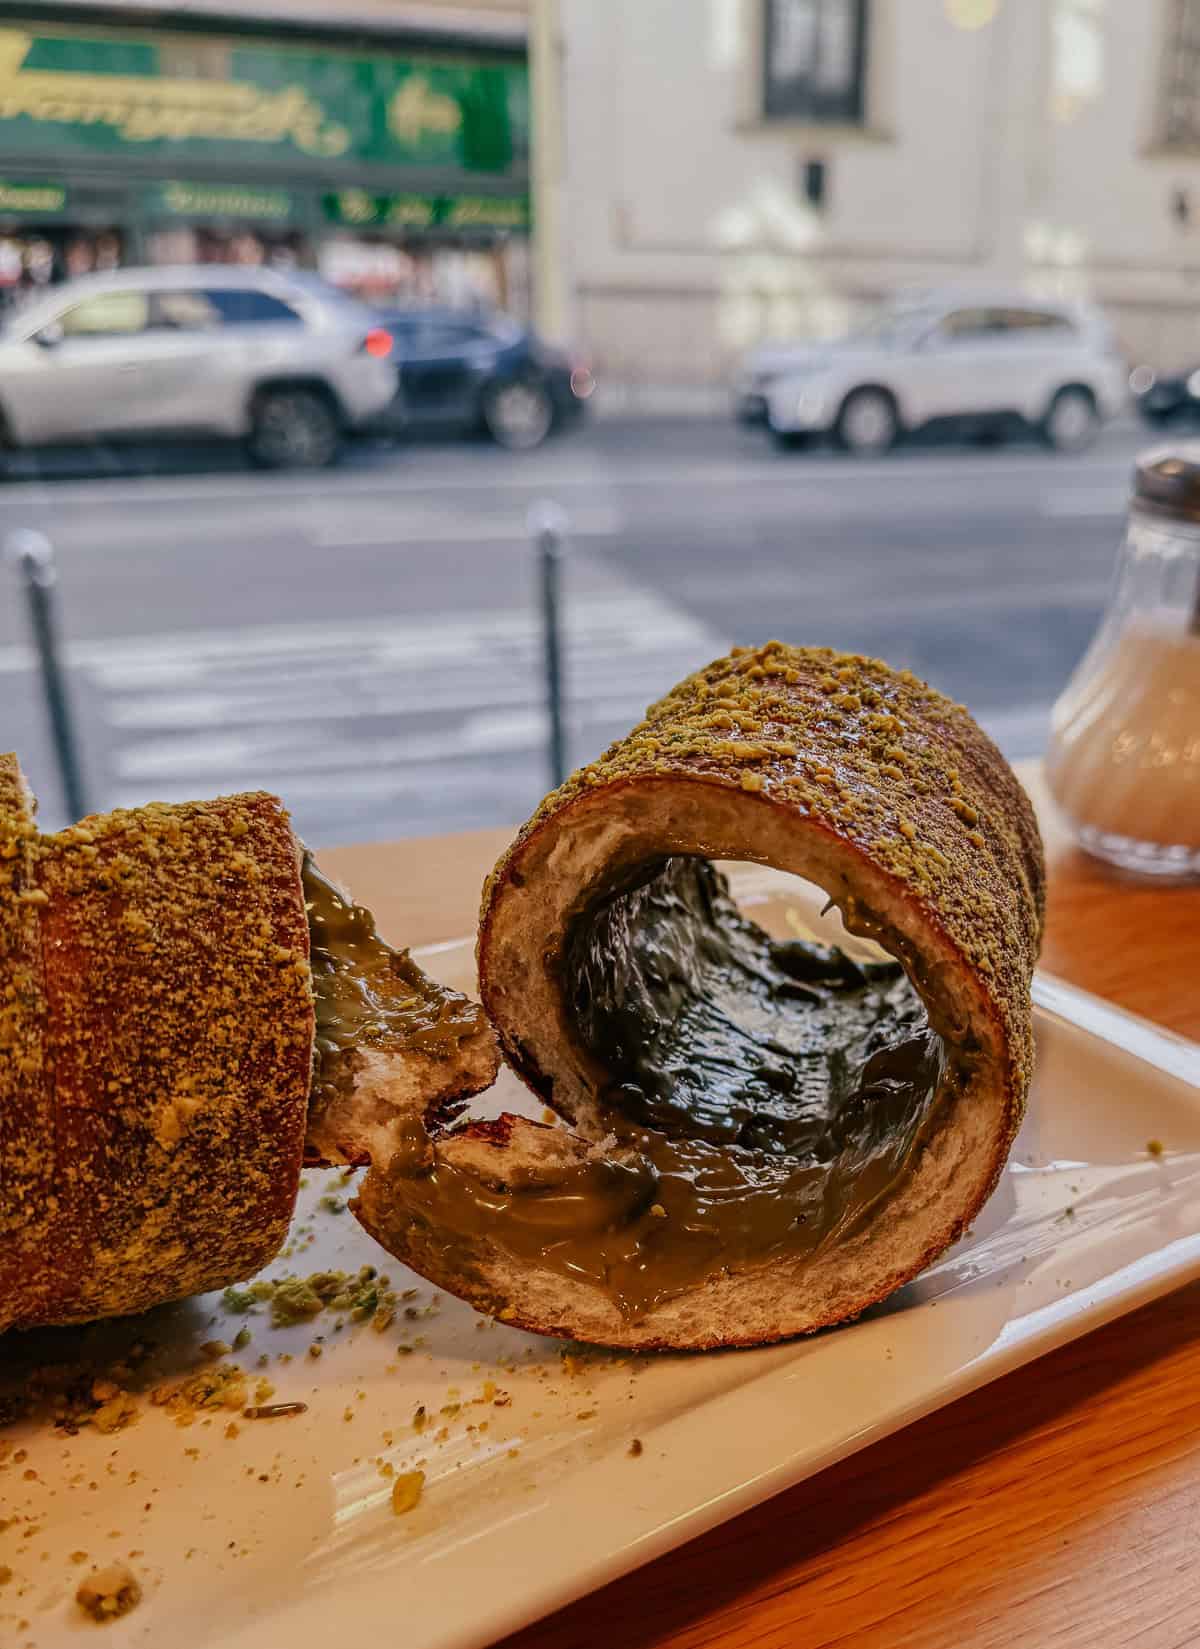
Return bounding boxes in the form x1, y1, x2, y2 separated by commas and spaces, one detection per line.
0, 869, 1200, 1649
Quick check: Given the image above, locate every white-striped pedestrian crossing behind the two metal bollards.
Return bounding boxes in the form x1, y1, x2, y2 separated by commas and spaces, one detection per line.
16, 587, 724, 815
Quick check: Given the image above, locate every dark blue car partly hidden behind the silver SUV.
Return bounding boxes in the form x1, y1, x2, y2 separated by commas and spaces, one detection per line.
377, 308, 595, 450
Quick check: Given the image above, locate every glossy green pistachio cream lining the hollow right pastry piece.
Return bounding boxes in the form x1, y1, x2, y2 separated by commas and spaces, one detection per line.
375, 857, 961, 1318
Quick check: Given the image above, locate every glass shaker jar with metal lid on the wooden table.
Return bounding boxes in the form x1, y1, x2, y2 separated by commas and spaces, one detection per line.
1045, 442, 1200, 877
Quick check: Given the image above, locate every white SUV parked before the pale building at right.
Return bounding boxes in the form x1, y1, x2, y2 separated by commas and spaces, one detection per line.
738, 295, 1129, 453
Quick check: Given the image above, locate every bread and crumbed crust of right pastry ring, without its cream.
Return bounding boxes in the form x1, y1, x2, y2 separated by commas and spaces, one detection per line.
464, 641, 1045, 1347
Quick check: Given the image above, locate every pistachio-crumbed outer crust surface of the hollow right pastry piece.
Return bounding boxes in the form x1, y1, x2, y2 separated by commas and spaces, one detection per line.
478, 641, 1045, 1097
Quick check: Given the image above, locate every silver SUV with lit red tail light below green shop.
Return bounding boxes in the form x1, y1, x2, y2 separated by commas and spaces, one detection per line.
0, 265, 397, 468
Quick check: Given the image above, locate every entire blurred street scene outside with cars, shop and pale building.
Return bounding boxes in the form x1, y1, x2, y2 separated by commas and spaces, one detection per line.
0, 0, 1200, 844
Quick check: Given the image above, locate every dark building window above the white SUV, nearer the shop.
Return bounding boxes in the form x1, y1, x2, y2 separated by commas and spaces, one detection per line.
763, 0, 869, 125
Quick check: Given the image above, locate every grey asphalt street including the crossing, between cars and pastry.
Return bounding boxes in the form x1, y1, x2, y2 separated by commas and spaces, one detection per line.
0, 419, 1147, 846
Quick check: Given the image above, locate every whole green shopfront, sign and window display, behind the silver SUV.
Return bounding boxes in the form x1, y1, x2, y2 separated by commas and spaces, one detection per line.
0, 23, 531, 313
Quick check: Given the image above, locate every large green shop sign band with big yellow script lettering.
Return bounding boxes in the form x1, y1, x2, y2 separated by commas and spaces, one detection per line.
0, 22, 529, 181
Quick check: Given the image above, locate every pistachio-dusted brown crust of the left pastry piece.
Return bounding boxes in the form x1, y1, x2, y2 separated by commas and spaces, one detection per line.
0, 757, 313, 1329
